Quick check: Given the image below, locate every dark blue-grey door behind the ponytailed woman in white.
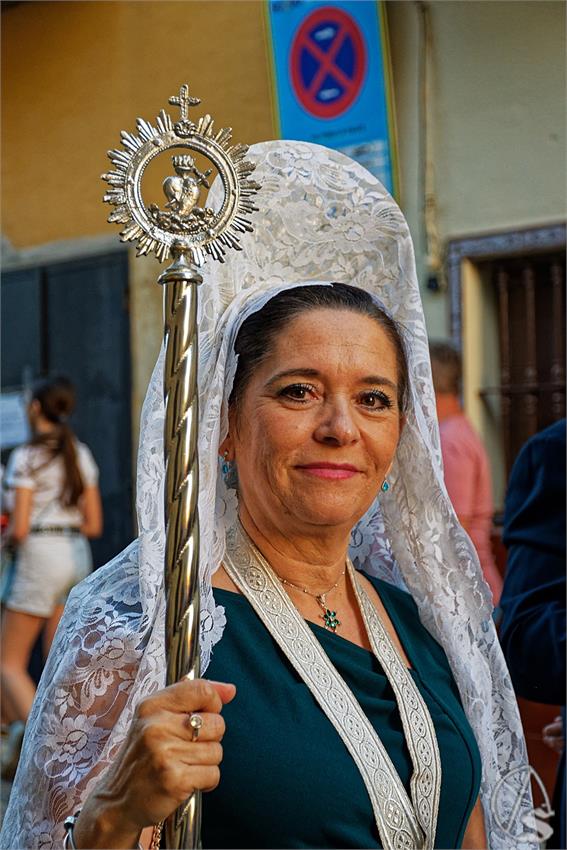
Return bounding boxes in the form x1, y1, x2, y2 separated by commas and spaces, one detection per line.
2, 253, 134, 566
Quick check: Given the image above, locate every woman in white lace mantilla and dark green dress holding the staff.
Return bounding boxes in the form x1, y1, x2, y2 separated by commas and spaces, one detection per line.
3, 142, 533, 848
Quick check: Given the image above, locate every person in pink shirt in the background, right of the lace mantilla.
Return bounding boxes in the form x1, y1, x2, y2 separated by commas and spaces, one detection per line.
429, 342, 502, 606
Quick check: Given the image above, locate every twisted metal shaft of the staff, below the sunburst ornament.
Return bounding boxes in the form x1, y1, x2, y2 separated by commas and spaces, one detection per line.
160, 256, 201, 850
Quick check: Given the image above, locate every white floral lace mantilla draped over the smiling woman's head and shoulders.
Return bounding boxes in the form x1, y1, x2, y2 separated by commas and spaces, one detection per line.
1, 141, 537, 850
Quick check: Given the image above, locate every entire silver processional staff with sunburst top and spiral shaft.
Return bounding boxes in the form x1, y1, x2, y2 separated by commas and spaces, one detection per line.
102, 85, 260, 850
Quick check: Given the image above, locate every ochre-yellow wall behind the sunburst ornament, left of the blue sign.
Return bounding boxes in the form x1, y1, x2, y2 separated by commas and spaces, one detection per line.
2, 0, 274, 248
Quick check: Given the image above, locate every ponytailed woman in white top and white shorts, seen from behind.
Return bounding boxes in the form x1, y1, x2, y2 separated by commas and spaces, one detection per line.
0, 377, 102, 722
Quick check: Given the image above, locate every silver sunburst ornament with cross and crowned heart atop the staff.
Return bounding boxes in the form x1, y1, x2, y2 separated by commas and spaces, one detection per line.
102, 84, 259, 266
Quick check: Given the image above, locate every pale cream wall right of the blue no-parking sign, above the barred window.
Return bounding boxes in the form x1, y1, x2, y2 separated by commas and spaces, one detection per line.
387, 0, 566, 337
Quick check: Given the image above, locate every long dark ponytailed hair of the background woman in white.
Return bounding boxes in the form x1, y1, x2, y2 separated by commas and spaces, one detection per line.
30, 376, 84, 507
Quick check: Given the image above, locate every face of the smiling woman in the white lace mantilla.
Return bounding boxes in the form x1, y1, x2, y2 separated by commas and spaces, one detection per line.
226, 308, 403, 534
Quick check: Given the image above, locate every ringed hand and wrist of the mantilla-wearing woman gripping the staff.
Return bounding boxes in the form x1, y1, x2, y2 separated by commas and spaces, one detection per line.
74, 679, 236, 848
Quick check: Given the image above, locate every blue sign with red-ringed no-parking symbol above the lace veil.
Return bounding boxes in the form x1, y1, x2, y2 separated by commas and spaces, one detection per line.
267, 0, 397, 194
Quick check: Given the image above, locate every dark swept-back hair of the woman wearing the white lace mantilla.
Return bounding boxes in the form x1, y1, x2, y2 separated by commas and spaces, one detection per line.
229, 283, 408, 412
